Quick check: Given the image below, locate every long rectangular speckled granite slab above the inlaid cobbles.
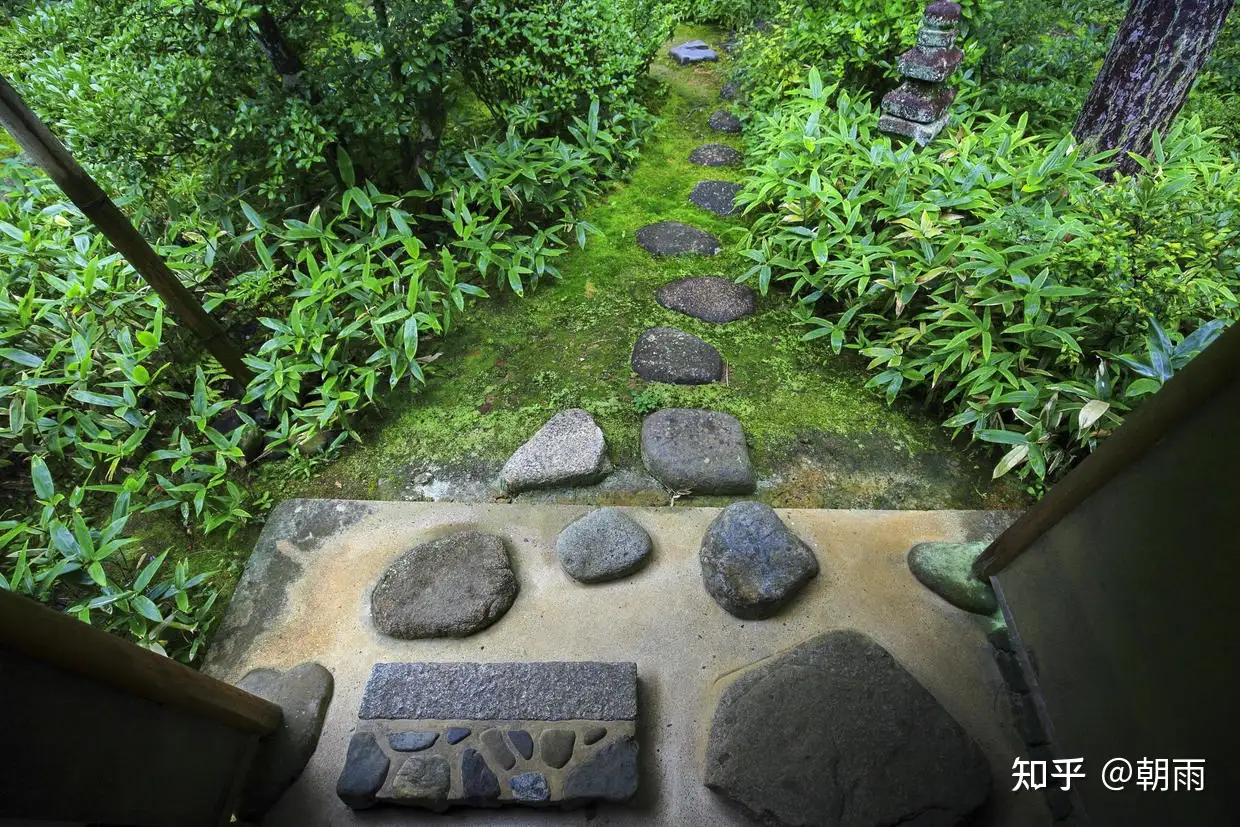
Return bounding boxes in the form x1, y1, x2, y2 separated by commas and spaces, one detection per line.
357, 661, 637, 720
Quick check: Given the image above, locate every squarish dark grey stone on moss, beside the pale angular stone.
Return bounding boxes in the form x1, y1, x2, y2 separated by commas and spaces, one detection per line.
641, 408, 758, 493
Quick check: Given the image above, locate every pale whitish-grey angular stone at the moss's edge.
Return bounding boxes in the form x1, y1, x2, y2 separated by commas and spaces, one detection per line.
500, 408, 611, 493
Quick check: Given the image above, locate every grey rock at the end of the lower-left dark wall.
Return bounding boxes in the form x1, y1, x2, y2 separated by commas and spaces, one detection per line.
237, 663, 335, 821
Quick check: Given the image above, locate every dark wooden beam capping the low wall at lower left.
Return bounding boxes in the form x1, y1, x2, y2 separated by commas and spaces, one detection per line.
0, 590, 283, 736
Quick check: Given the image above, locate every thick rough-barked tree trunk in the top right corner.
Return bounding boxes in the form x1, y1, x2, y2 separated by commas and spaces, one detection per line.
1073, 0, 1234, 175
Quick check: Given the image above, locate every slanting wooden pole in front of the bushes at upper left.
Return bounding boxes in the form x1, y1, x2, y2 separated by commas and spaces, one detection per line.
0, 74, 254, 386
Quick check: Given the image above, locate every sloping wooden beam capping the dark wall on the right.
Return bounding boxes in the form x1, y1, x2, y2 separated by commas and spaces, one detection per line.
973, 324, 1240, 580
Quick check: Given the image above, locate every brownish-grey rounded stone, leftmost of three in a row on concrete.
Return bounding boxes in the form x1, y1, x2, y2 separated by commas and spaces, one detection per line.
371, 531, 517, 640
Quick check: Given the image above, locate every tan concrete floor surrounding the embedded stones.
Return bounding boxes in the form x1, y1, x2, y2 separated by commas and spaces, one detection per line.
206, 500, 1049, 827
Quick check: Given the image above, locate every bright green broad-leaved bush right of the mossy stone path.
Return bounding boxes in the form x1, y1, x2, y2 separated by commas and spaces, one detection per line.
738, 71, 1240, 481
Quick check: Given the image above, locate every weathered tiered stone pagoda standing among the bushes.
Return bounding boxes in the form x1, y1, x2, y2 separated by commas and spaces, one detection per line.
878, 0, 965, 146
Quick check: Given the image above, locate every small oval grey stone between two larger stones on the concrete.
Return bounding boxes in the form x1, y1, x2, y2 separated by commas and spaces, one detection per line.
556, 508, 652, 585
